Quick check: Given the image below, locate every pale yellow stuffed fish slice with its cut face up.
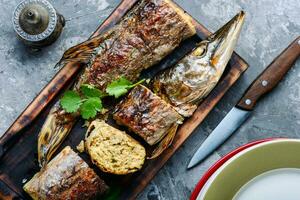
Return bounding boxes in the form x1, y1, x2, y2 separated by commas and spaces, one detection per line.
85, 120, 146, 175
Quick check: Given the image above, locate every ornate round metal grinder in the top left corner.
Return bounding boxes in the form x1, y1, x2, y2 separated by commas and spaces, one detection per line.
13, 0, 65, 48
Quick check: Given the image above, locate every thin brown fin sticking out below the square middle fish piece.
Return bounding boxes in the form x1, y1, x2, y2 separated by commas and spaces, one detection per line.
147, 124, 178, 160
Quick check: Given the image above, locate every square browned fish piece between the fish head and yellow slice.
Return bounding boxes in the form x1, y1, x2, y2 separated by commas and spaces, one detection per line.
113, 85, 183, 145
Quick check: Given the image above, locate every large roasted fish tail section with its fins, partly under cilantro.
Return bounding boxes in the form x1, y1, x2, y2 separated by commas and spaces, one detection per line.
38, 0, 196, 166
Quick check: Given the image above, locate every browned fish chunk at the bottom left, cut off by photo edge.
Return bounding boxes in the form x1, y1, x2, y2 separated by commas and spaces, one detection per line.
24, 146, 108, 200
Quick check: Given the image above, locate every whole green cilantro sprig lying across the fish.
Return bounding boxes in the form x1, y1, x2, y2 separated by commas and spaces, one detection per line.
60, 77, 145, 119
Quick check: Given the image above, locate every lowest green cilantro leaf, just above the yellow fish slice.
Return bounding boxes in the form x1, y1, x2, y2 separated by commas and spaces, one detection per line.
80, 97, 102, 119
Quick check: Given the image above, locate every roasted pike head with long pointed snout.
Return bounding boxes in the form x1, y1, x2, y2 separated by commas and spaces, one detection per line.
151, 11, 245, 117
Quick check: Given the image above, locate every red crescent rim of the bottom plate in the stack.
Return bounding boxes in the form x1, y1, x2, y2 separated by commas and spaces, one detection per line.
190, 138, 279, 200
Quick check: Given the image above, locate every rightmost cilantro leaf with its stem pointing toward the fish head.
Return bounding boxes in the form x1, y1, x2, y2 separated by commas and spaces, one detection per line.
106, 77, 144, 98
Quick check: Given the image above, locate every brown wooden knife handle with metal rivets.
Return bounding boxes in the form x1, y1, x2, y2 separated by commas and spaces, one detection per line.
236, 36, 300, 110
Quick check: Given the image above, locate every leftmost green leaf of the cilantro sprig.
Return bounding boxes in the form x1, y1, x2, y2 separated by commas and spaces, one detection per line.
60, 90, 82, 113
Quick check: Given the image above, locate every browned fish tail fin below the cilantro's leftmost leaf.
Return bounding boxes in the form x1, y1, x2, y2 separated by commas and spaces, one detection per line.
38, 105, 76, 168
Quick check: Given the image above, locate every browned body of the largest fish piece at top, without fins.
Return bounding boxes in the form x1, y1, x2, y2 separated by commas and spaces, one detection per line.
65, 0, 196, 90
